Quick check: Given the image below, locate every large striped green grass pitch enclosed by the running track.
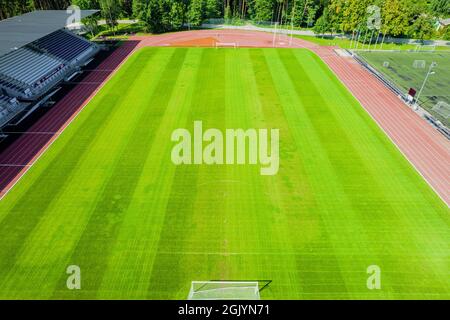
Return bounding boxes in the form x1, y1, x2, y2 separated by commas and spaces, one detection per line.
0, 48, 450, 299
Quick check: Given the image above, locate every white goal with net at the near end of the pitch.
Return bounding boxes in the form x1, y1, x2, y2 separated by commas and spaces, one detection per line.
188, 281, 260, 300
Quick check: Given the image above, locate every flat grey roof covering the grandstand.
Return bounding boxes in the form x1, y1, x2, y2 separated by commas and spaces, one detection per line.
0, 10, 98, 56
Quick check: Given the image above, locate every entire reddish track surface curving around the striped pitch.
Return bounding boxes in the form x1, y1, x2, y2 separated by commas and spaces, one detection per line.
0, 29, 450, 205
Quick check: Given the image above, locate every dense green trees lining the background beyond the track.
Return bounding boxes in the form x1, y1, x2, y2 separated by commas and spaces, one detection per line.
0, 0, 450, 39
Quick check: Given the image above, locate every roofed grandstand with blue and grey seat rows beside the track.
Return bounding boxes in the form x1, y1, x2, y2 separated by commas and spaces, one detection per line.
0, 10, 100, 129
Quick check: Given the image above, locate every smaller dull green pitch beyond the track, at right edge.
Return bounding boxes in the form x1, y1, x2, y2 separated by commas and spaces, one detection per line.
358, 51, 450, 127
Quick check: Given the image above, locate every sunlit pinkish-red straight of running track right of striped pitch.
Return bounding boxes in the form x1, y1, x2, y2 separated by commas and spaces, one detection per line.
314, 47, 450, 206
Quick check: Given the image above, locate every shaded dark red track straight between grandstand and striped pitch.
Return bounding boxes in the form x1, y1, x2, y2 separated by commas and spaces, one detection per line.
0, 41, 138, 198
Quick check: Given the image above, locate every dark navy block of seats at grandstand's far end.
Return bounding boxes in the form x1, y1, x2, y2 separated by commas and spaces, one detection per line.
31, 30, 96, 63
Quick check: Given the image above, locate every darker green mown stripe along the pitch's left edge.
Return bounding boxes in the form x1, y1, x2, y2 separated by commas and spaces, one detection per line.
0, 48, 158, 282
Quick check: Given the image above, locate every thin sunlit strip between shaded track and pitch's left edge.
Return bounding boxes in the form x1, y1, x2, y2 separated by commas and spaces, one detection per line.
0, 45, 140, 201
